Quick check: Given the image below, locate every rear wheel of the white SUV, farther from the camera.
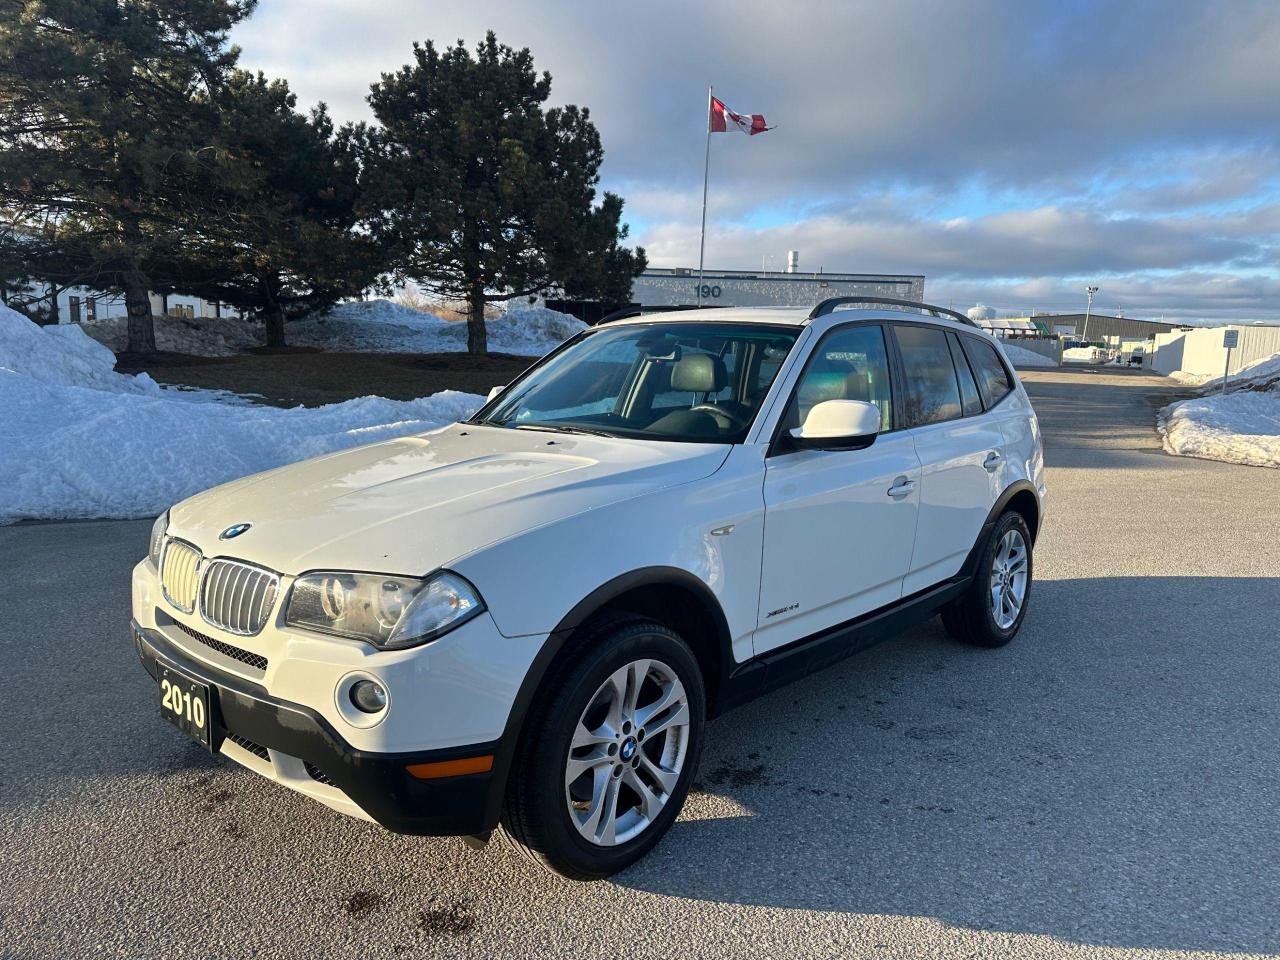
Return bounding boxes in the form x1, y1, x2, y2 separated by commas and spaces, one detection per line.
941, 511, 1032, 646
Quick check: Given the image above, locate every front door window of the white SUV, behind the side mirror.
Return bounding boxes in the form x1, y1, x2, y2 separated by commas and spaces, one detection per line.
783, 324, 893, 433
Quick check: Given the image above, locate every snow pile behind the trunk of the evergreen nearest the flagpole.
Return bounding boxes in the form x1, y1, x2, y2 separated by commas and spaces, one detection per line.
287, 300, 586, 357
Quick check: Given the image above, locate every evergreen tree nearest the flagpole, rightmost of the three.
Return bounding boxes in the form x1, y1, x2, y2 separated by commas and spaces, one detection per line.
347, 32, 644, 353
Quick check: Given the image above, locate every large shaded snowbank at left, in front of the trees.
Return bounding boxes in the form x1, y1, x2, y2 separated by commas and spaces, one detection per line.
0, 306, 483, 524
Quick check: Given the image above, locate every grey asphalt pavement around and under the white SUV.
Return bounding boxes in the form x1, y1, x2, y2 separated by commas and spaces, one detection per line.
0, 369, 1280, 957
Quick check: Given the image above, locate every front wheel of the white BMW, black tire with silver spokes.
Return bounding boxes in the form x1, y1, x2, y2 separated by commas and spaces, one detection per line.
502, 620, 707, 881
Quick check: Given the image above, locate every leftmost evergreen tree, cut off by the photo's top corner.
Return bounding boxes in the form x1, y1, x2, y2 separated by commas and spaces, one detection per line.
0, 0, 256, 353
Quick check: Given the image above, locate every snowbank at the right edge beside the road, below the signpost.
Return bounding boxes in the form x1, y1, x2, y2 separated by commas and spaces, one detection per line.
1156, 353, 1280, 467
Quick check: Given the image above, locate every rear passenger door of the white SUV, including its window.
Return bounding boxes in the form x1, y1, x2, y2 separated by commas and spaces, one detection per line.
892, 321, 1005, 594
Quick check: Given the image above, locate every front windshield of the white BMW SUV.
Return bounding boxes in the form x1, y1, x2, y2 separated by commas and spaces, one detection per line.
474, 323, 799, 443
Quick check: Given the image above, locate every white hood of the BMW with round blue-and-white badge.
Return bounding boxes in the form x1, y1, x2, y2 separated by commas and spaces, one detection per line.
169, 424, 730, 576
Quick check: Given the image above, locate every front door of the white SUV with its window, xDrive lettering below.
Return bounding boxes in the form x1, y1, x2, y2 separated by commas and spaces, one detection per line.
754, 323, 920, 654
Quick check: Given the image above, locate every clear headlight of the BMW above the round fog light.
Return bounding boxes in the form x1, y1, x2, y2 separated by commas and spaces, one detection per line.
285, 570, 484, 650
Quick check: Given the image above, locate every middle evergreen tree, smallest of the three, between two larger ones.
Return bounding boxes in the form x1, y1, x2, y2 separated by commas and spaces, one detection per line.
180, 70, 384, 347
